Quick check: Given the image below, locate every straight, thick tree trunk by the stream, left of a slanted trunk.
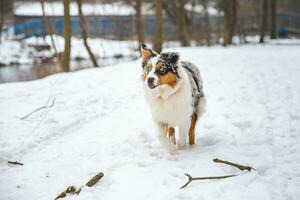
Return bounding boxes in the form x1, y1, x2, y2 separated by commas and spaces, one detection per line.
63, 0, 72, 72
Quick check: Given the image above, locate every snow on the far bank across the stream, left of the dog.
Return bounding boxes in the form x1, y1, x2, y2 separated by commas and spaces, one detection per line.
0, 35, 139, 68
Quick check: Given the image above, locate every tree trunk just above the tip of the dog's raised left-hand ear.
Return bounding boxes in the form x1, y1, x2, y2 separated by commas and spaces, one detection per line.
134, 0, 144, 46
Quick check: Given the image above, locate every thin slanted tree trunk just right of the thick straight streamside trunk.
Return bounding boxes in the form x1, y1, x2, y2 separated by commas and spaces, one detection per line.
76, 0, 98, 67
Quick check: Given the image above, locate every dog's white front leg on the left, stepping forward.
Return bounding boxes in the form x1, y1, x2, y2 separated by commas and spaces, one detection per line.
154, 122, 176, 154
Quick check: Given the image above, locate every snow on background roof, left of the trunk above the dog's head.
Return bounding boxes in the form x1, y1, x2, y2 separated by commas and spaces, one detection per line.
14, 1, 154, 16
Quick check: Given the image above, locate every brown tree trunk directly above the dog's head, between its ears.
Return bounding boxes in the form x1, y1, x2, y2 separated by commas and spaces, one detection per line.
154, 0, 163, 53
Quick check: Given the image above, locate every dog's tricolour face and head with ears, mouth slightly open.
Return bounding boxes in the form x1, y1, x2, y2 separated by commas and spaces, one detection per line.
141, 44, 179, 90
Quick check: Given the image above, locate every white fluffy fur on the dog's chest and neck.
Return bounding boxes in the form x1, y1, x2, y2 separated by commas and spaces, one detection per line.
144, 68, 193, 126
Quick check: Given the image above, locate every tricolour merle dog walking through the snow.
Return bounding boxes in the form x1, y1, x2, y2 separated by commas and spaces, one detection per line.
141, 44, 206, 154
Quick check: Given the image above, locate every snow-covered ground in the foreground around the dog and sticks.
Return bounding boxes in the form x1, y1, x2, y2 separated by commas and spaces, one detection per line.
0, 41, 300, 200
